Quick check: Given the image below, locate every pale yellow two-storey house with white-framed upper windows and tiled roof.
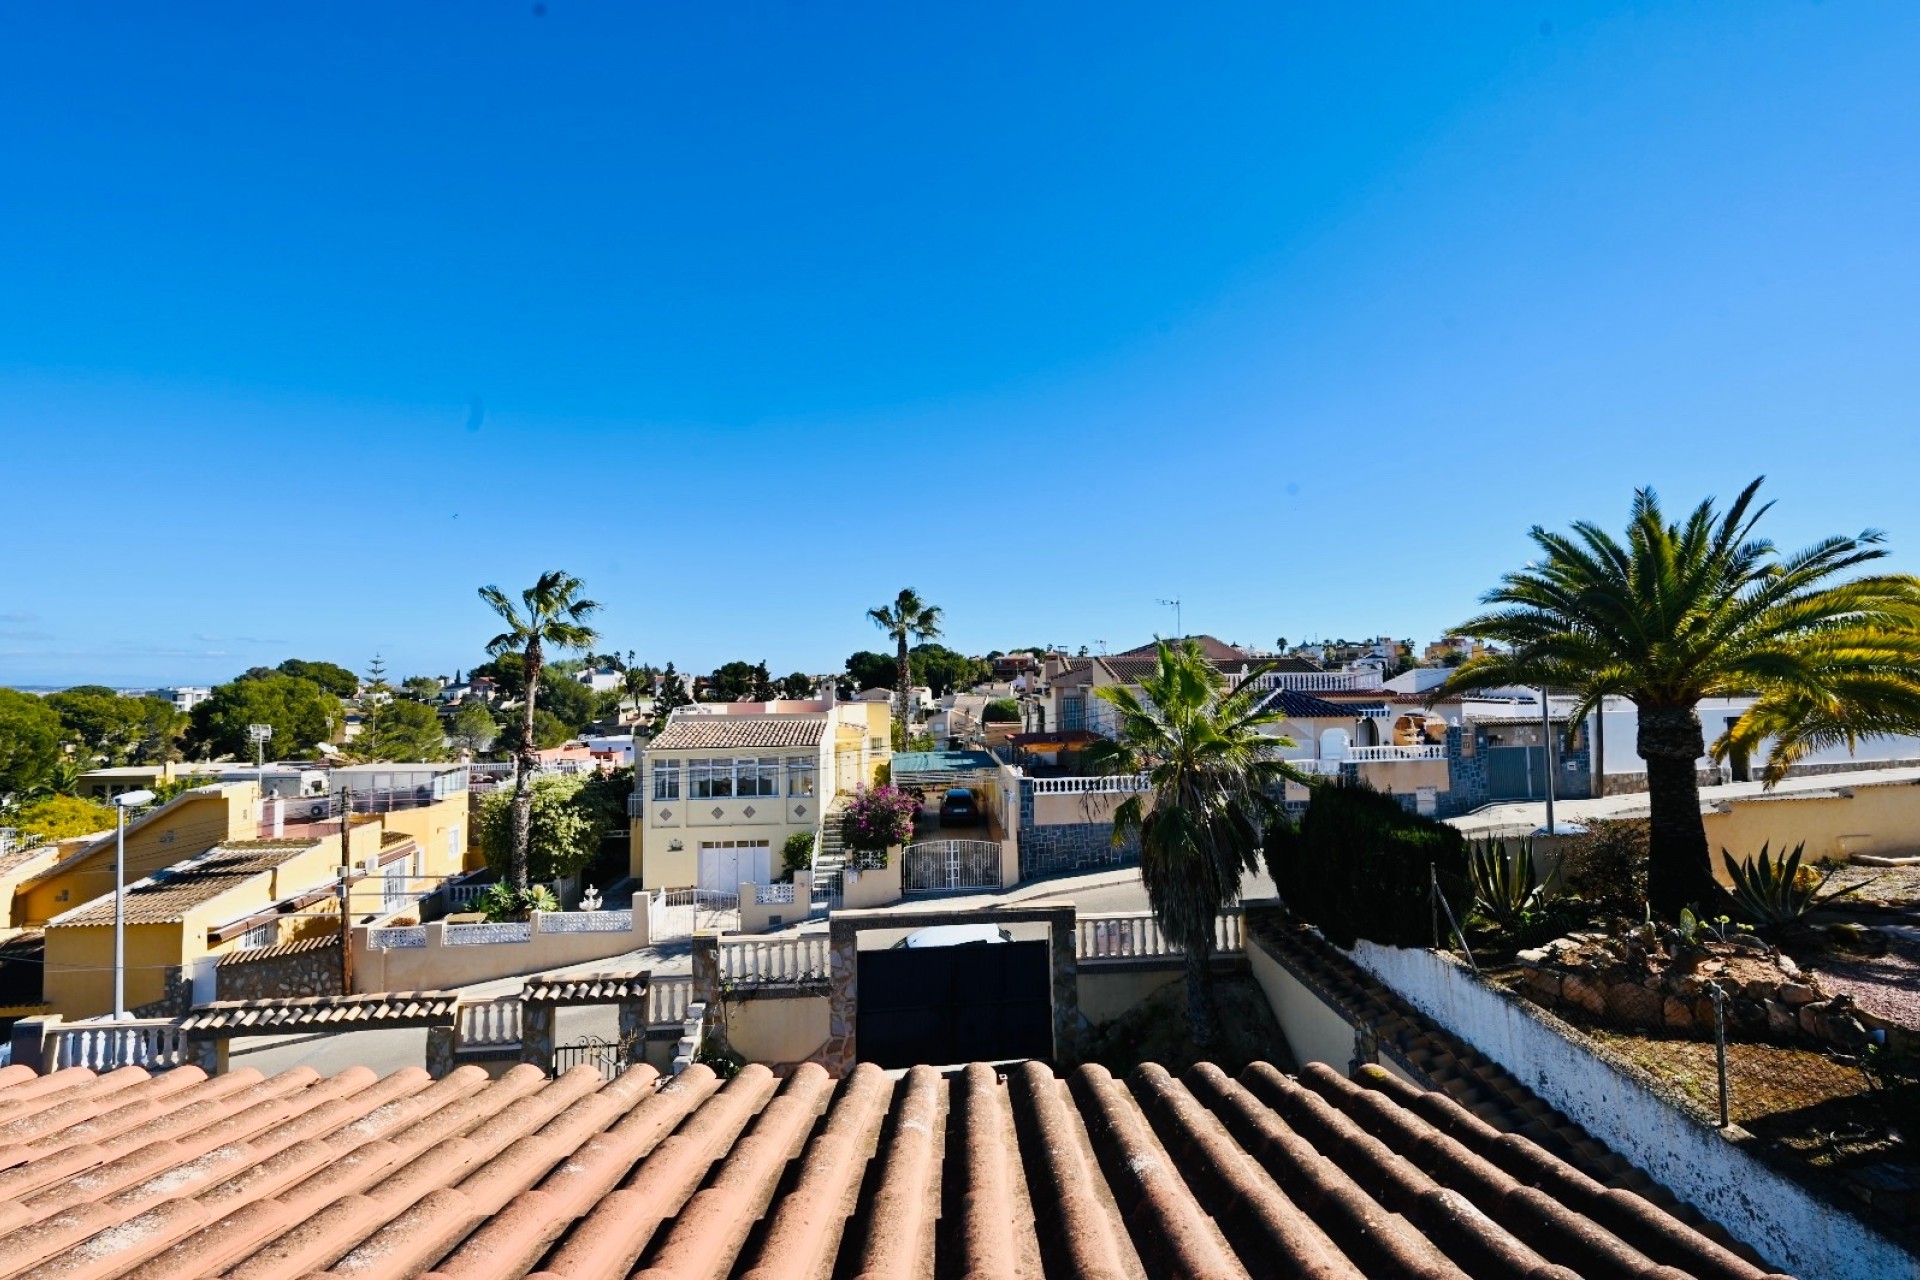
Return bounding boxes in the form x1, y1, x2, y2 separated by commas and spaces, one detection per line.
632, 700, 893, 892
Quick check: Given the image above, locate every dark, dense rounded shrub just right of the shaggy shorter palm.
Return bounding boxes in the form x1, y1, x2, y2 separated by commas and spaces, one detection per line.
1267, 781, 1473, 946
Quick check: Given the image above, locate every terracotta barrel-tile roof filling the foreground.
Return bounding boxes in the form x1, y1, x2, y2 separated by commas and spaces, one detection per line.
0, 1063, 1763, 1280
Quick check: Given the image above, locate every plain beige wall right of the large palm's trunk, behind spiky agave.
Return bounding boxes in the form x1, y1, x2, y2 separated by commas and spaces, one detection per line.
1707, 783, 1920, 879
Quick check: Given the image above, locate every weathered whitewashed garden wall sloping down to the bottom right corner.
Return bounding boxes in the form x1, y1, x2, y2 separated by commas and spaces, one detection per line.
1344, 940, 1914, 1280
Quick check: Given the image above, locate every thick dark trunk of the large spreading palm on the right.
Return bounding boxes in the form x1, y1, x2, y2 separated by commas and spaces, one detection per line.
1638, 706, 1722, 919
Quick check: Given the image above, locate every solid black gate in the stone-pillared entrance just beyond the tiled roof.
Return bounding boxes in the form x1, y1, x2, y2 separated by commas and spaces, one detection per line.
856, 942, 1054, 1067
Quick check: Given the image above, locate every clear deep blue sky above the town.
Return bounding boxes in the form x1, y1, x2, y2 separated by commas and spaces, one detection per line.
0, 0, 1920, 683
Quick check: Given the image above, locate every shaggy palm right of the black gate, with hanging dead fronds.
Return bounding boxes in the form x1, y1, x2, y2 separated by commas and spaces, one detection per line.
1085, 639, 1308, 1046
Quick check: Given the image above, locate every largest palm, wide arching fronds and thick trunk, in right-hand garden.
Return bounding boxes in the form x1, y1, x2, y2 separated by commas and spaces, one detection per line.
1432, 480, 1920, 917
